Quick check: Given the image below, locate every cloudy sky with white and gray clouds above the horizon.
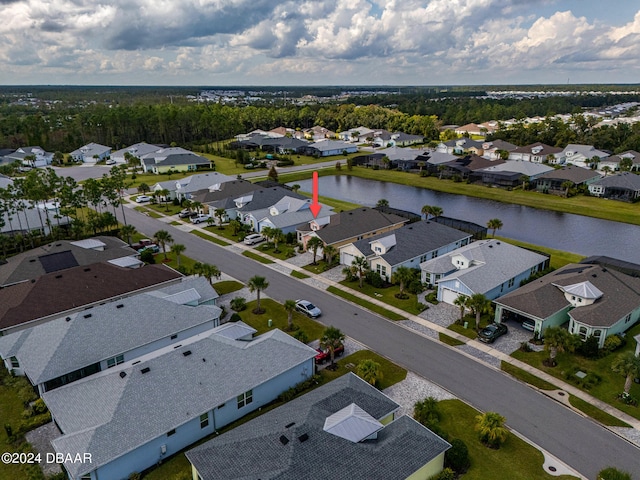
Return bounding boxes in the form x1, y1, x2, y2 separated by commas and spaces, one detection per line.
0, 0, 640, 86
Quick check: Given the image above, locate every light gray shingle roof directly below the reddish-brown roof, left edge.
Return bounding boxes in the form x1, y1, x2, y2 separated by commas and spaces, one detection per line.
0, 279, 221, 384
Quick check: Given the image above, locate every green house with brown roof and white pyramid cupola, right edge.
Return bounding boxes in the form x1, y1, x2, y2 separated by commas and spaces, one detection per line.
495, 263, 640, 348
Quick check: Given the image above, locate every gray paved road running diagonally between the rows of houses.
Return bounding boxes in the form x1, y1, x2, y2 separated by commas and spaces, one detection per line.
127, 210, 640, 479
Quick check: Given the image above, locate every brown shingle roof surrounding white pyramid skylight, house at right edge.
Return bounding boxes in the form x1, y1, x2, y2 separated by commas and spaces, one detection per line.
496, 263, 640, 327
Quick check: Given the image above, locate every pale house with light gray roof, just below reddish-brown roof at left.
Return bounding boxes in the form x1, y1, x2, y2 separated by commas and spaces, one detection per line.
0, 277, 222, 395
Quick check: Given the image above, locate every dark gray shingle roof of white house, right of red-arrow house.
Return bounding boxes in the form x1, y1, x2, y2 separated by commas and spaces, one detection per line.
353, 220, 471, 266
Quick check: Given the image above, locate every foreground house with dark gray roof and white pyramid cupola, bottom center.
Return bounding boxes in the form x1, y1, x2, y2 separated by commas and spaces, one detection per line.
186, 373, 450, 480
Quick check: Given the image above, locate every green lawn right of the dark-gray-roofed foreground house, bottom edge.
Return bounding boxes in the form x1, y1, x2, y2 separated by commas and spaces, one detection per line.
438, 400, 575, 480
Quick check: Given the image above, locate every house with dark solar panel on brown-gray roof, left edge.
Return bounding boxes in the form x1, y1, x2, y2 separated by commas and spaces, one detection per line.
0, 236, 142, 286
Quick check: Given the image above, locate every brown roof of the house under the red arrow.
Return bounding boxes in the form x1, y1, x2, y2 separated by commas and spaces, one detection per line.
307, 207, 408, 245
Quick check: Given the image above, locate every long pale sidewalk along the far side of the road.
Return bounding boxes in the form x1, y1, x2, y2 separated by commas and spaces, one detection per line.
126, 197, 640, 440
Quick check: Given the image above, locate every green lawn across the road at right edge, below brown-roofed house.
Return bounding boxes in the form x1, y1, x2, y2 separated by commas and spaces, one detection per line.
512, 324, 640, 419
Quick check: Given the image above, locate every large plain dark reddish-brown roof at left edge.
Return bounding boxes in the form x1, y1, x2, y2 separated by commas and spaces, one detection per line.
0, 262, 182, 330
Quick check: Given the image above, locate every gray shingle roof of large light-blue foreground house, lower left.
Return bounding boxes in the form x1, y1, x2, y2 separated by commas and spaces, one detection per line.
43, 327, 317, 476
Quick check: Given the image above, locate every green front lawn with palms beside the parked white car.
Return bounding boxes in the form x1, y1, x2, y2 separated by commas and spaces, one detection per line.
240, 298, 326, 341
